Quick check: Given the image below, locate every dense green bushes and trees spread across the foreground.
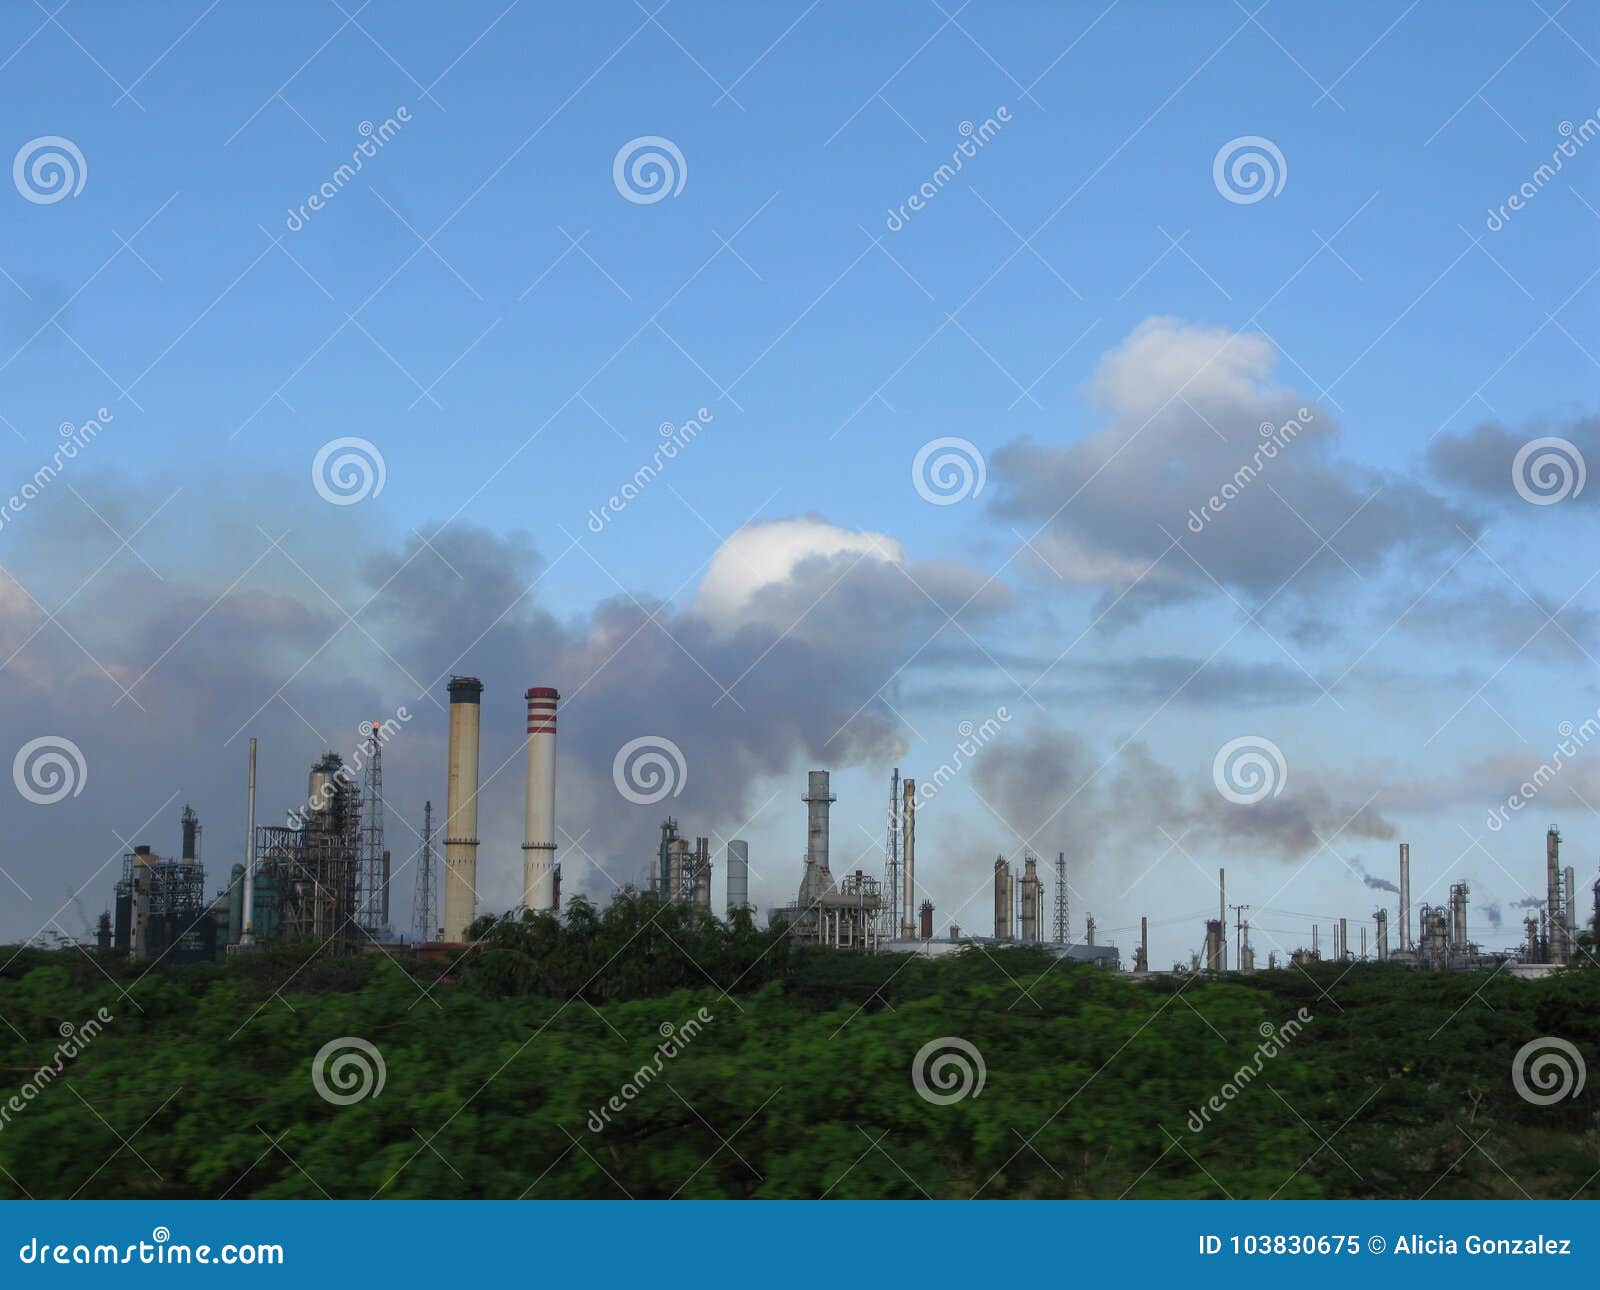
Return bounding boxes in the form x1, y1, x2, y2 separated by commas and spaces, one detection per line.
0, 898, 1600, 1197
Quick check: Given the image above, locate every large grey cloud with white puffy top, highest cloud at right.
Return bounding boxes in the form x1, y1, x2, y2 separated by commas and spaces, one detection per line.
990, 318, 1477, 616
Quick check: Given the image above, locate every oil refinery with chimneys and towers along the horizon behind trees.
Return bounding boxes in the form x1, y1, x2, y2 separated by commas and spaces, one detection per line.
96, 675, 1600, 976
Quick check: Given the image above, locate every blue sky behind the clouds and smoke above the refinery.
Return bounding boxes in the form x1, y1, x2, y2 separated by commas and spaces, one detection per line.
0, 0, 1600, 962
